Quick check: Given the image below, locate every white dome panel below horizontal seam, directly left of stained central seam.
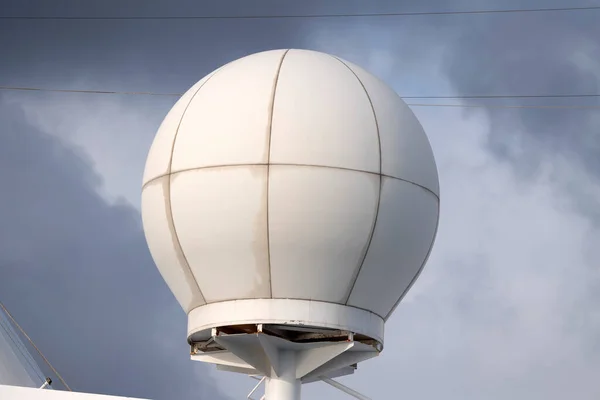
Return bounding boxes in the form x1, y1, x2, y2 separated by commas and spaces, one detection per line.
171, 165, 270, 302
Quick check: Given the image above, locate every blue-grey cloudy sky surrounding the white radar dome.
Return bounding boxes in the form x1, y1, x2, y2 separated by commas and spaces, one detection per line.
0, 0, 600, 400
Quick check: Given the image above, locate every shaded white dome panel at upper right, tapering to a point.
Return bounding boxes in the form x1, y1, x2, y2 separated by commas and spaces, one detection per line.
344, 61, 439, 196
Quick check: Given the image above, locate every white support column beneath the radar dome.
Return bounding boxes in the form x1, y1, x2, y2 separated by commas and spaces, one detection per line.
265, 350, 302, 400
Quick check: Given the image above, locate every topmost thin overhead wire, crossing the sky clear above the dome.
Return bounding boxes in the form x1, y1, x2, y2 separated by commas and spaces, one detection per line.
0, 6, 600, 20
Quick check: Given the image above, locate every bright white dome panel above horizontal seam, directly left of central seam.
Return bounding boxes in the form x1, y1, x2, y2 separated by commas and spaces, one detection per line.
171, 50, 285, 172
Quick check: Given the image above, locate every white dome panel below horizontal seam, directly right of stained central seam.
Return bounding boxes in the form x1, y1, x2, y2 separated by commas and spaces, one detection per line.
269, 165, 379, 302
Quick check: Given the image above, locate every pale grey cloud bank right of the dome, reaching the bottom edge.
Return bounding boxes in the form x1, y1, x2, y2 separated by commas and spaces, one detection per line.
360, 110, 600, 399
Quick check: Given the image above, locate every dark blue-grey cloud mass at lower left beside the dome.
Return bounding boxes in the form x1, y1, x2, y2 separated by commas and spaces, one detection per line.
0, 97, 224, 399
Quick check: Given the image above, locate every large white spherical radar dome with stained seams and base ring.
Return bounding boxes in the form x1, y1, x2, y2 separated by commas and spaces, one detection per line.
142, 50, 439, 341
